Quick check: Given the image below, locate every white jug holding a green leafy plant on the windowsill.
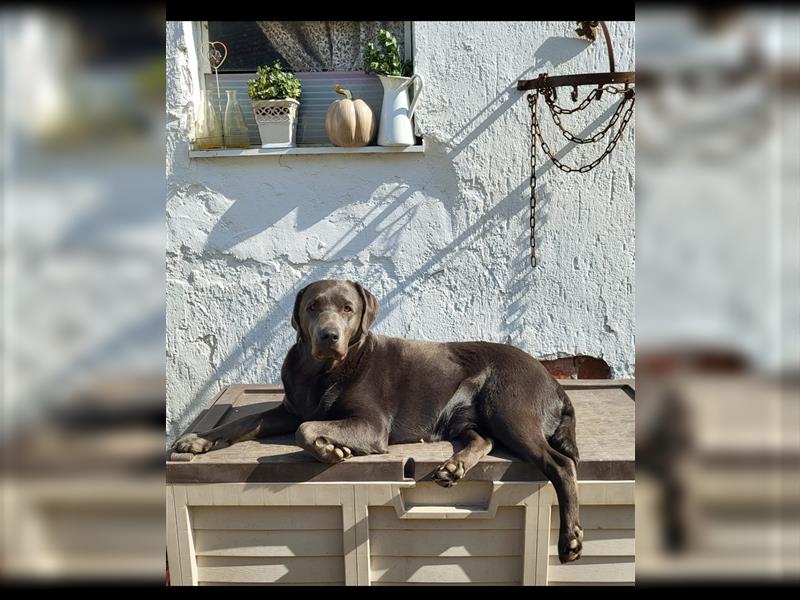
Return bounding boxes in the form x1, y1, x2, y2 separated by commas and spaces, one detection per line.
364, 29, 422, 146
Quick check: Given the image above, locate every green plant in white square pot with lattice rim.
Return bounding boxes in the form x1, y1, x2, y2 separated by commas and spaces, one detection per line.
247, 60, 300, 148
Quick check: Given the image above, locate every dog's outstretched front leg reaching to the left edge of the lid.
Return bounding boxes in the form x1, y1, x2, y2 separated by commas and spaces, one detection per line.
172, 404, 300, 454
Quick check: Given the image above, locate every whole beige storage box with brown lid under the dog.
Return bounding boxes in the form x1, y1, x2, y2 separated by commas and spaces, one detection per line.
167, 380, 635, 585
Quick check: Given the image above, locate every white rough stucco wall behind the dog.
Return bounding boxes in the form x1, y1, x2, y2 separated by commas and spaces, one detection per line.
166, 22, 634, 440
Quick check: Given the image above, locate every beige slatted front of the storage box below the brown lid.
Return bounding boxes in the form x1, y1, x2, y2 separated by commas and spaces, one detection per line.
168, 481, 635, 585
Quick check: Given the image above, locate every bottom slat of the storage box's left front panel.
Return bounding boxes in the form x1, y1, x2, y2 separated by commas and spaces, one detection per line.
197, 556, 344, 583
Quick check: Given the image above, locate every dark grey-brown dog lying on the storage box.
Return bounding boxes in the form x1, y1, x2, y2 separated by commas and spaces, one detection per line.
173, 280, 583, 563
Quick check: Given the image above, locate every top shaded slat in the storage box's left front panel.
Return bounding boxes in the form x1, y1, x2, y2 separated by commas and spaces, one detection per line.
191, 506, 342, 531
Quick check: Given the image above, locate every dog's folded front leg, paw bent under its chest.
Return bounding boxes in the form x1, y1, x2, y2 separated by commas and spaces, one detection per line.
296, 417, 389, 463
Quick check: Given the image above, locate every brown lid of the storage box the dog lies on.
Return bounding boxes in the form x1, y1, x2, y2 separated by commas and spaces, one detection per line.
167, 380, 635, 483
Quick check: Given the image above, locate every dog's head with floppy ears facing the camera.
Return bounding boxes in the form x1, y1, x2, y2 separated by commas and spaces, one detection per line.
292, 279, 378, 360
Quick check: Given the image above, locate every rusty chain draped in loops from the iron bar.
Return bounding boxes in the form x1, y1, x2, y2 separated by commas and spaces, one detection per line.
528, 86, 636, 267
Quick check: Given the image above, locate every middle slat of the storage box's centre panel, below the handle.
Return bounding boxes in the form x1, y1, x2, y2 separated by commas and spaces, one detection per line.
370, 529, 522, 557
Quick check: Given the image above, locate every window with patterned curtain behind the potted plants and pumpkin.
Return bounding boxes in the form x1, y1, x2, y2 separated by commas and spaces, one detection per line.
203, 21, 412, 146
